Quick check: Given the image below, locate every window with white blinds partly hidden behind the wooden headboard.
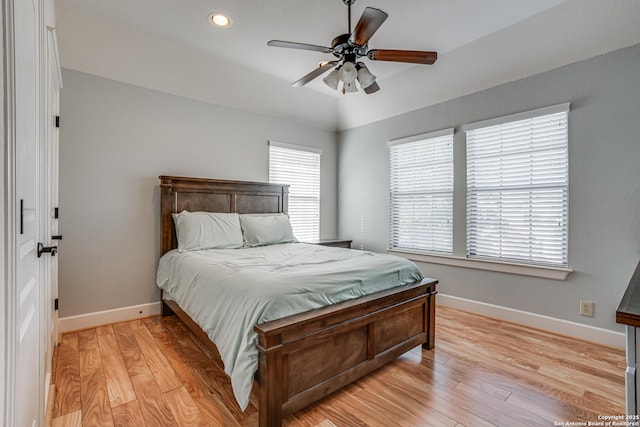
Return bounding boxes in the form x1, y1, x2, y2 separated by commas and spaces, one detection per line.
269, 141, 322, 241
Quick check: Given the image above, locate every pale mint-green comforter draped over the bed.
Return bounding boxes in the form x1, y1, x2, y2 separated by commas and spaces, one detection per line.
157, 243, 422, 410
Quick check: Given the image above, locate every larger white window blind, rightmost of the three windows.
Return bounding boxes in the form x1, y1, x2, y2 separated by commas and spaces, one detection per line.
464, 104, 569, 267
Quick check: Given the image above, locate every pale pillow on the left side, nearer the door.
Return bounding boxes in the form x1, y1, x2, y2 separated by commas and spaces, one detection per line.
173, 211, 243, 252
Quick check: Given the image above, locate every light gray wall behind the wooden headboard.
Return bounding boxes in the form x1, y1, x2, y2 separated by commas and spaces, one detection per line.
59, 69, 337, 317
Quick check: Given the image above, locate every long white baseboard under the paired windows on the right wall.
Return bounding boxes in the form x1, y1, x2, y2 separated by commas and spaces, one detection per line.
436, 293, 625, 350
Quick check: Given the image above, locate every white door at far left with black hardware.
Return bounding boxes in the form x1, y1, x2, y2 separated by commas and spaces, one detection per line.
7, 0, 44, 427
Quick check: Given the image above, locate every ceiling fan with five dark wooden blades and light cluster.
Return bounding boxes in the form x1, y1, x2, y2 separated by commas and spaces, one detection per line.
267, 0, 438, 94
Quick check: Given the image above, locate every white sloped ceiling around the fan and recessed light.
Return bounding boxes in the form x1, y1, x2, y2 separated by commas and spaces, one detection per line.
56, 0, 640, 130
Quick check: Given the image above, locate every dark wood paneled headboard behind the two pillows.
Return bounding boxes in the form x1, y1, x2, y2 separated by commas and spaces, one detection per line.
160, 176, 289, 255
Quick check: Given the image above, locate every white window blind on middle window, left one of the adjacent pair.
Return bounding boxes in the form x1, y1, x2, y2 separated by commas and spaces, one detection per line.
389, 129, 453, 253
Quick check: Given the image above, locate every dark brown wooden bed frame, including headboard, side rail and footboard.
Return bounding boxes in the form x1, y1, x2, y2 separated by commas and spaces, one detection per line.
160, 176, 438, 426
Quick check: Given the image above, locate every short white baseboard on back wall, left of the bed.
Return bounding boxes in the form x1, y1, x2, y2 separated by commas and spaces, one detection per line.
58, 302, 160, 333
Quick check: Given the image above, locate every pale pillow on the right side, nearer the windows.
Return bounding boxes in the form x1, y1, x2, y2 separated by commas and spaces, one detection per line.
240, 214, 298, 246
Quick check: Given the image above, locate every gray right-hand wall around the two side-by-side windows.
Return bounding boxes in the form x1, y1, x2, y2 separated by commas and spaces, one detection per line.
338, 45, 640, 330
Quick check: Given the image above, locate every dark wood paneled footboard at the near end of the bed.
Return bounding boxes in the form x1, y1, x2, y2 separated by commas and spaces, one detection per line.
254, 279, 437, 426
